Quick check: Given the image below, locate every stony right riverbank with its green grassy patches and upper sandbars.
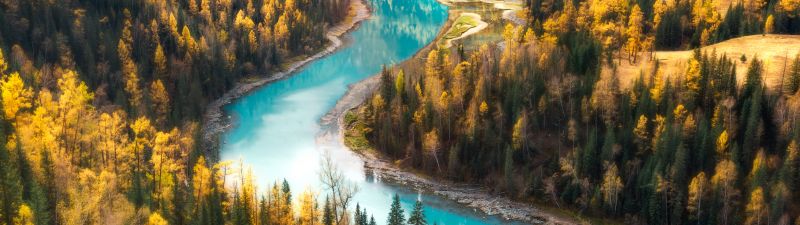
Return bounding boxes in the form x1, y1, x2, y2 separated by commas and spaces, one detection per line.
320, 0, 594, 224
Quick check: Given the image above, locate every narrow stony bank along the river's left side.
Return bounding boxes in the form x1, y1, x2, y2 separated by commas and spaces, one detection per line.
202, 0, 370, 161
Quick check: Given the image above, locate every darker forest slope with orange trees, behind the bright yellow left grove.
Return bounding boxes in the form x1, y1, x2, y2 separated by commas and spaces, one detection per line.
0, 0, 350, 127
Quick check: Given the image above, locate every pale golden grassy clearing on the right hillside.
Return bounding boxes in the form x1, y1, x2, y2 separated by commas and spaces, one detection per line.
603, 35, 800, 90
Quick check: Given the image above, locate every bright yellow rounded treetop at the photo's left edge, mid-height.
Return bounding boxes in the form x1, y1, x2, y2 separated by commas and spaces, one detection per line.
0, 72, 33, 122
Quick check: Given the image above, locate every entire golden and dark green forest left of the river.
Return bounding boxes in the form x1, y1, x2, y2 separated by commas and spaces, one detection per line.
0, 0, 358, 224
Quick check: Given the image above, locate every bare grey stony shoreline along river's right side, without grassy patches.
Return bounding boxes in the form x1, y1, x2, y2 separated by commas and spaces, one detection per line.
317, 4, 580, 224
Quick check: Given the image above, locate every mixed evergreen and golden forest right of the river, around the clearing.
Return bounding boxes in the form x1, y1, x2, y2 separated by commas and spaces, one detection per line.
345, 0, 800, 224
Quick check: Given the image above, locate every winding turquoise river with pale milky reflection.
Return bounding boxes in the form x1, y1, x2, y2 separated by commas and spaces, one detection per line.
221, 0, 520, 225
